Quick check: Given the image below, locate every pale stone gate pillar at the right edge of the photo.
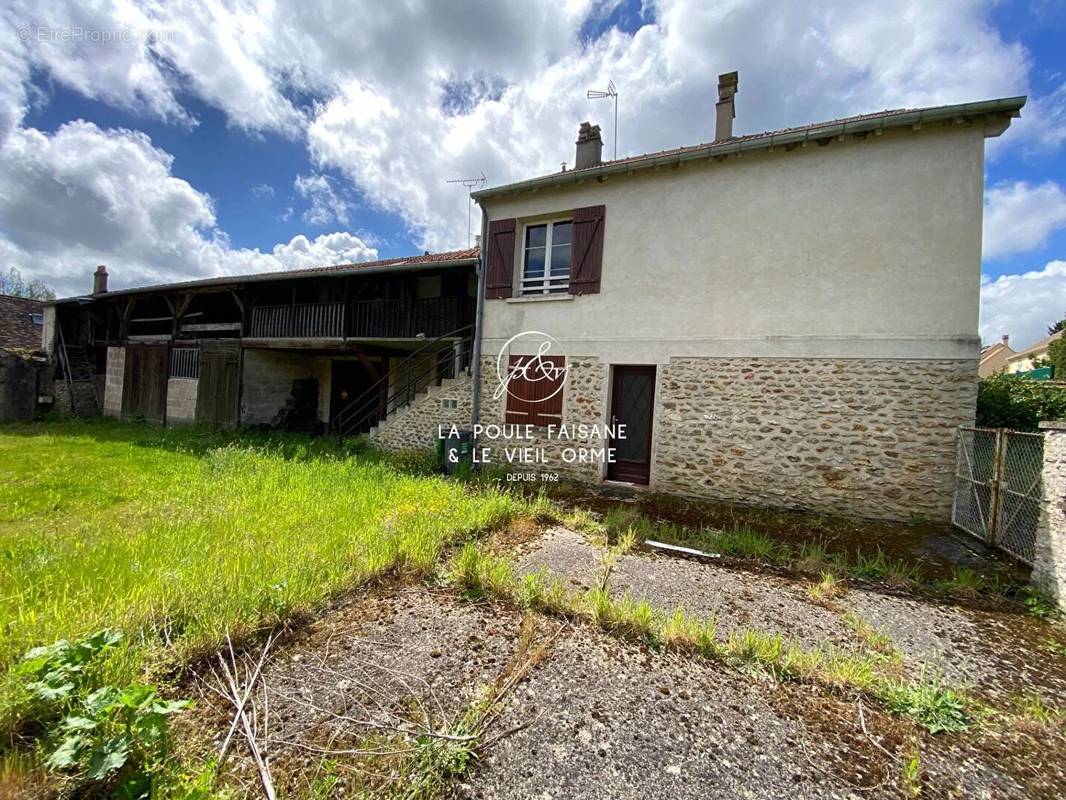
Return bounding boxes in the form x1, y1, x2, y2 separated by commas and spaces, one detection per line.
1032, 422, 1066, 610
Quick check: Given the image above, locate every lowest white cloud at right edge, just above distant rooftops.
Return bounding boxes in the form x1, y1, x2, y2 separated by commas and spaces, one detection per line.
981, 260, 1066, 350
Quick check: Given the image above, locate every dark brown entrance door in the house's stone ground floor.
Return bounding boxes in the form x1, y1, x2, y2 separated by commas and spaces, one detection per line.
607, 366, 656, 483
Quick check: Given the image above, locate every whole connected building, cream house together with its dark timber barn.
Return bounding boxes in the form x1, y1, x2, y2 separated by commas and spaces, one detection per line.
46, 74, 1025, 522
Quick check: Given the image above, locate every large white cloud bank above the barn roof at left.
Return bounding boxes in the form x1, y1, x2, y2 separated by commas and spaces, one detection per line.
0, 121, 377, 295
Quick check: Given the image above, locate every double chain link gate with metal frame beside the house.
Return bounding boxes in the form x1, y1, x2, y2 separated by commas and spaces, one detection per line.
952, 428, 1044, 564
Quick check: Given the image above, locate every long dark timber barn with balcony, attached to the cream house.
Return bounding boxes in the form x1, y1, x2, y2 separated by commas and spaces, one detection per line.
45, 249, 478, 434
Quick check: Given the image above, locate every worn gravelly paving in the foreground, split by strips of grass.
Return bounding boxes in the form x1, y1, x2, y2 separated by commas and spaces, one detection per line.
189, 528, 1066, 798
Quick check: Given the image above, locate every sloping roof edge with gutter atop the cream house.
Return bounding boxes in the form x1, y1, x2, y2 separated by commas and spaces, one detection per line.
471, 96, 1028, 201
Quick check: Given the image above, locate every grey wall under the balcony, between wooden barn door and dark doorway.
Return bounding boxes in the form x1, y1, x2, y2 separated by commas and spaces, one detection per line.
241, 350, 330, 425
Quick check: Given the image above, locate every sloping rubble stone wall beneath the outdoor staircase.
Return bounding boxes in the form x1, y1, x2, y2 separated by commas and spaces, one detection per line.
370, 375, 473, 450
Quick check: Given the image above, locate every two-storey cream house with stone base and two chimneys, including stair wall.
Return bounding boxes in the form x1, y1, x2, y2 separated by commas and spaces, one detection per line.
375, 74, 1025, 522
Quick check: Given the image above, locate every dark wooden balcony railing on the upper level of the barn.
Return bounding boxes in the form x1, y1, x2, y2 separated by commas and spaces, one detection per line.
248, 298, 472, 339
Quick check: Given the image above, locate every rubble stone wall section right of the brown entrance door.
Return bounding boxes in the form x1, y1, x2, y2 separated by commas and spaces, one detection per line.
651, 358, 976, 522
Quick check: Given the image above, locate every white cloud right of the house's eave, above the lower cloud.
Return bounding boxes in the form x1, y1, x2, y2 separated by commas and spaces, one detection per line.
983, 180, 1066, 259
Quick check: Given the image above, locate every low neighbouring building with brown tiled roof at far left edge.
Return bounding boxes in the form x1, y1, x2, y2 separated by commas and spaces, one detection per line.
0, 294, 49, 419
